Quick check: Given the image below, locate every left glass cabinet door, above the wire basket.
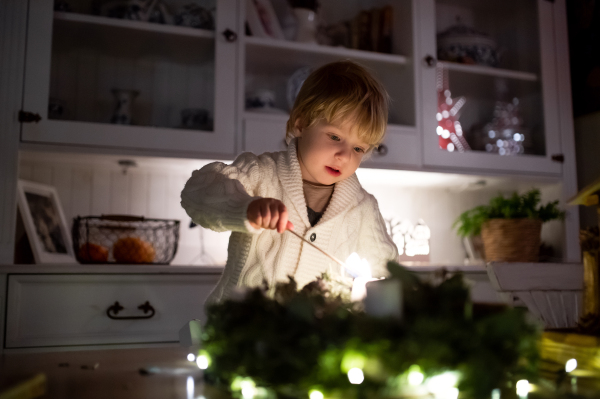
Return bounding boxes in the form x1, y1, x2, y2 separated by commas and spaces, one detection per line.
22, 0, 236, 158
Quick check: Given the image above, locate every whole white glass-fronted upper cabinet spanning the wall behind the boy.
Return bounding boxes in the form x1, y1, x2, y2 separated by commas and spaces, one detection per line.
21, 0, 574, 177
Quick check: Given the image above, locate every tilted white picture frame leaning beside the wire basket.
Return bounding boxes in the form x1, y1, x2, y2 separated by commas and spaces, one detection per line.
17, 180, 77, 264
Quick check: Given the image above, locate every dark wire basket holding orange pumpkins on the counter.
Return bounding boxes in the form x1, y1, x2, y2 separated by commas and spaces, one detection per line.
72, 215, 179, 265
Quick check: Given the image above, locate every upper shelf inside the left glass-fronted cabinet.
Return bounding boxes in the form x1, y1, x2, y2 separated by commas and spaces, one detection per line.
54, 12, 215, 41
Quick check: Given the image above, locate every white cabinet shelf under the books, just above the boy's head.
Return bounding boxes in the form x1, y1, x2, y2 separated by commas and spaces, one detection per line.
245, 36, 408, 70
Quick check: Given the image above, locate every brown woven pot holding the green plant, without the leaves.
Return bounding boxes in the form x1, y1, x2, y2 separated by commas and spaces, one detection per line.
481, 219, 542, 262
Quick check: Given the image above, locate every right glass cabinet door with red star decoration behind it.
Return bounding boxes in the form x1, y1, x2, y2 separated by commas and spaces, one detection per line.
417, 0, 561, 174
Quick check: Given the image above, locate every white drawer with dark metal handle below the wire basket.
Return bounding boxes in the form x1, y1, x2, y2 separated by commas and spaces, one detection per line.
5, 274, 220, 348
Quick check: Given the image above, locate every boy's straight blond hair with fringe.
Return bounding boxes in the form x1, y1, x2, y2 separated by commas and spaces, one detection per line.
286, 61, 389, 149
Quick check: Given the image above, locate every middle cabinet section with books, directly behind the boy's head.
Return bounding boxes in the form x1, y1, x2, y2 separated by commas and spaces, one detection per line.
238, 0, 420, 166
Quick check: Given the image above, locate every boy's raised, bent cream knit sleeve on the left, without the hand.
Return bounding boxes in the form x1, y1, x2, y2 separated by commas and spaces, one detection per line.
181, 153, 268, 233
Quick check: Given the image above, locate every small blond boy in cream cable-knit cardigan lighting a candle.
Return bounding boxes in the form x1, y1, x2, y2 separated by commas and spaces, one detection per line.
181, 61, 398, 302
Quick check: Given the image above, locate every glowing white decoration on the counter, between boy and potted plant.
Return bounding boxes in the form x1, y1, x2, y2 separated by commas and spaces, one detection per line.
385, 218, 431, 261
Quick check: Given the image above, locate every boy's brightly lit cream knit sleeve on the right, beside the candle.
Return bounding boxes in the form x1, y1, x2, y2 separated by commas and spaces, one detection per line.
358, 194, 398, 278
